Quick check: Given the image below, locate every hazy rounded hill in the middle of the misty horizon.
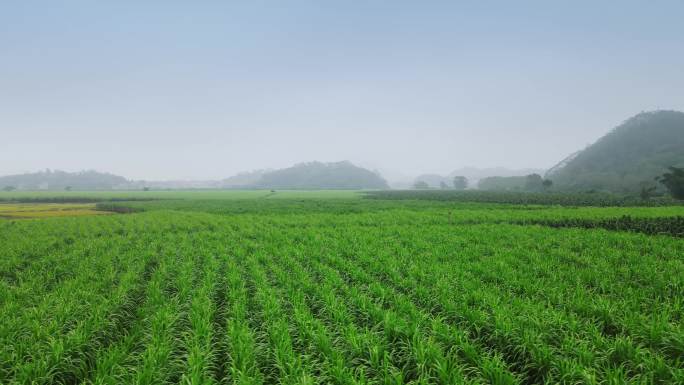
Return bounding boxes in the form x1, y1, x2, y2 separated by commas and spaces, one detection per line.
227, 161, 388, 190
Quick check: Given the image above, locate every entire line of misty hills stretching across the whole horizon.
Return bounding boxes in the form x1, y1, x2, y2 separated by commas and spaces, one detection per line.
0, 111, 684, 193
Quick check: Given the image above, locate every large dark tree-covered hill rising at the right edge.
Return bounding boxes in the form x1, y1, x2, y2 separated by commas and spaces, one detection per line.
545, 111, 684, 193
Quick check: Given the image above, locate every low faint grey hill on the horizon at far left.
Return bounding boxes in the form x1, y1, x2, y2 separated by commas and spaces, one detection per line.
0, 170, 128, 190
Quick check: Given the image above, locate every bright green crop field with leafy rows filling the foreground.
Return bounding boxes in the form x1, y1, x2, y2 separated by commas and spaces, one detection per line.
0, 191, 684, 384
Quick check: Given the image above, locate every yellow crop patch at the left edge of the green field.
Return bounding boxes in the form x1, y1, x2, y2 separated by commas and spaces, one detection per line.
0, 203, 111, 219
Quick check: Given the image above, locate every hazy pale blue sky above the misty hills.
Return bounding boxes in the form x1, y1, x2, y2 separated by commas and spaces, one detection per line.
0, 0, 684, 179
